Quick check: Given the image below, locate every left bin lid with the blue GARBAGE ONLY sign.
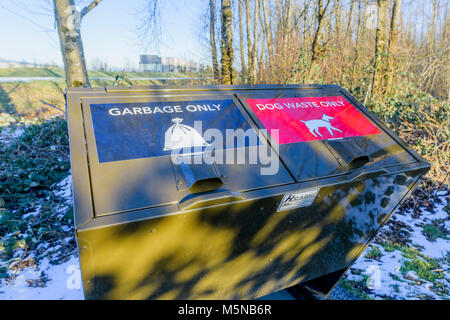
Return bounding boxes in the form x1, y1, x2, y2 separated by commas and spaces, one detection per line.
81, 92, 294, 216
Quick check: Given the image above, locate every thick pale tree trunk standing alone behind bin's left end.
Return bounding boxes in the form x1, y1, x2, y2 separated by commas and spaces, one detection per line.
53, 0, 90, 88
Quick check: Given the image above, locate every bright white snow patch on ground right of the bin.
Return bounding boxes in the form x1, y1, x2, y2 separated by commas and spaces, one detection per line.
346, 192, 450, 299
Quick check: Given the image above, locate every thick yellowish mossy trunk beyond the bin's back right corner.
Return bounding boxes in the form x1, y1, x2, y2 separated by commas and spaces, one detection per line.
372, 0, 386, 95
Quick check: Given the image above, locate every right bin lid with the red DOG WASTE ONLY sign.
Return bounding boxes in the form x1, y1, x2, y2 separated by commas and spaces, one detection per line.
238, 86, 417, 182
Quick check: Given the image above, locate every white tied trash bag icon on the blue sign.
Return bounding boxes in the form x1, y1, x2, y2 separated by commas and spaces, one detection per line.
164, 118, 210, 151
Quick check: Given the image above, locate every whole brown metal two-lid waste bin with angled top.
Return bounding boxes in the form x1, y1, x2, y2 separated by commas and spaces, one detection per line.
66, 85, 430, 299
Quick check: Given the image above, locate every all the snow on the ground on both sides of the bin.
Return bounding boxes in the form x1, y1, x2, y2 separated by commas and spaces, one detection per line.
0, 170, 450, 300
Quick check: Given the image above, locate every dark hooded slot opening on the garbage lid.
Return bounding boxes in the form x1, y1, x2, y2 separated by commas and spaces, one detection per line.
170, 155, 225, 193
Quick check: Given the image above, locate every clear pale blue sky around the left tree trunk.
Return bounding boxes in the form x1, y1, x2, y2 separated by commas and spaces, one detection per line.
0, 0, 209, 68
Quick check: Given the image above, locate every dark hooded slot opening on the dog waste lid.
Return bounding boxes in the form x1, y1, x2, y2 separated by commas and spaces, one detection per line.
325, 139, 372, 169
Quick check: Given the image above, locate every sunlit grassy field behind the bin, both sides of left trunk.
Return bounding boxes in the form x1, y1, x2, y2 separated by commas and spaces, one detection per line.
0, 67, 211, 122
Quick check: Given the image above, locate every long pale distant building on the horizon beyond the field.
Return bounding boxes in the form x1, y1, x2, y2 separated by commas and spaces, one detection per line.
139, 54, 206, 72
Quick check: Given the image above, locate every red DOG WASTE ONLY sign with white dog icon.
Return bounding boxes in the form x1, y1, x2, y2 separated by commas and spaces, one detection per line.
246, 97, 382, 144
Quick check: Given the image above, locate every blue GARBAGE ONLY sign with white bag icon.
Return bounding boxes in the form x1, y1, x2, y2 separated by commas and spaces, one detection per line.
90, 100, 259, 163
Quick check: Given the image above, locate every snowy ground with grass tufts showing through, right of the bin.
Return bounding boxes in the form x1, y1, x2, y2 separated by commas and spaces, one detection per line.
346, 192, 450, 299
